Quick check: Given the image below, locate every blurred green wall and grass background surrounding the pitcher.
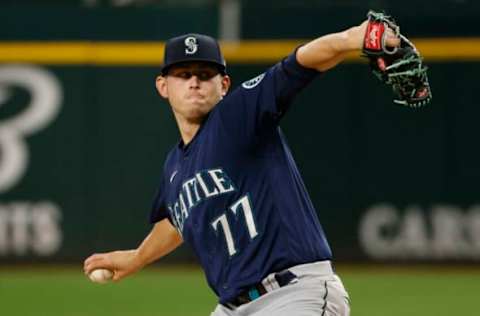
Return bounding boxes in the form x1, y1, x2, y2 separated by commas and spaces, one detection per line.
0, 0, 480, 316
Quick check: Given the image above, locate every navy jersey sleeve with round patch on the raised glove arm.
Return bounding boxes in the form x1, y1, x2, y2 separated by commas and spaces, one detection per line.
218, 51, 319, 141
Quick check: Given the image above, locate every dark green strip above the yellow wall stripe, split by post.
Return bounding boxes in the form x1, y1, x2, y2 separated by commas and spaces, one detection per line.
0, 0, 480, 41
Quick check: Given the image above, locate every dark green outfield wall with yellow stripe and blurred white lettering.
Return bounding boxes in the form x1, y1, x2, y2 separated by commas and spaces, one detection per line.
0, 5, 480, 263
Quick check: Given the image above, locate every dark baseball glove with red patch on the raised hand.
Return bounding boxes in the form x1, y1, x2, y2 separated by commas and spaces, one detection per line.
363, 11, 432, 108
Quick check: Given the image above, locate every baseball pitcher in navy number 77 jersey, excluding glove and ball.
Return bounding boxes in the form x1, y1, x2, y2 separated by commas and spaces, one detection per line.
84, 12, 418, 316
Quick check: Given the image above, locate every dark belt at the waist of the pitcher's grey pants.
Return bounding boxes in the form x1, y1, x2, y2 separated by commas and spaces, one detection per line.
224, 270, 297, 308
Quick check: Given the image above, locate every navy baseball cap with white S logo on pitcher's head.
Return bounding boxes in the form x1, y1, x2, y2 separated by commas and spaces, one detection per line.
161, 33, 227, 75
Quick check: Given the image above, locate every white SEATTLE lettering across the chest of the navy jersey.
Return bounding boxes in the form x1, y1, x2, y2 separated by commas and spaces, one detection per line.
167, 168, 235, 235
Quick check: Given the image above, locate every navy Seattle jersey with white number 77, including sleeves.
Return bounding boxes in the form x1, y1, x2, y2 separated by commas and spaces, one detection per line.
151, 54, 331, 303
